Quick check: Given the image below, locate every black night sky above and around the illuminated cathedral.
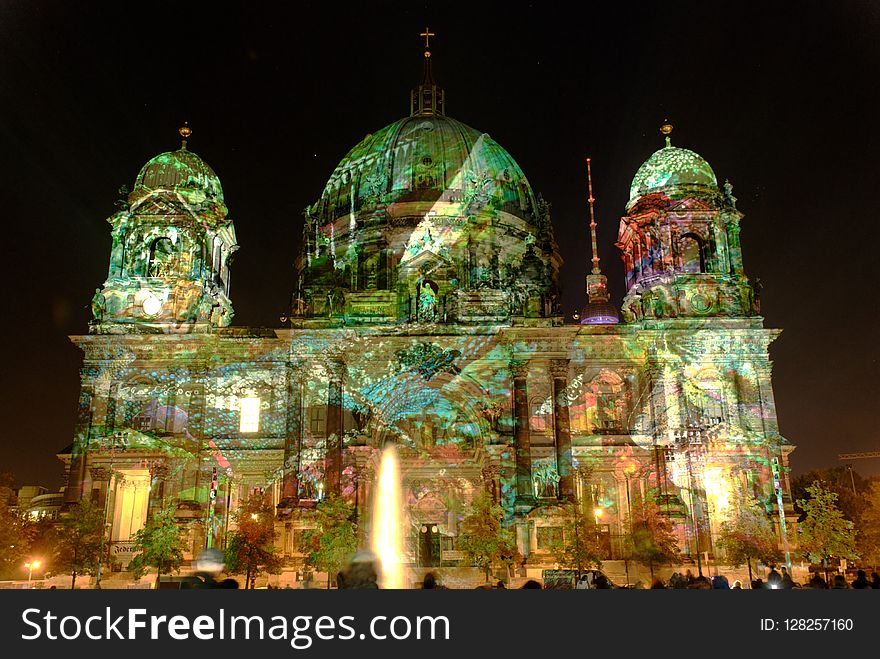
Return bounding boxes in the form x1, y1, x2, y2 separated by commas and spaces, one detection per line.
0, 0, 880, 487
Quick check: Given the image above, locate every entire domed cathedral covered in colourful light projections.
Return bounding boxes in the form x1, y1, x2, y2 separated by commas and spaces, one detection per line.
59, 37, 796, 584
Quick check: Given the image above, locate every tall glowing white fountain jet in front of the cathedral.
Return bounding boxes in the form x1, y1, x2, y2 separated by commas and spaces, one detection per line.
372, 444, 406, 588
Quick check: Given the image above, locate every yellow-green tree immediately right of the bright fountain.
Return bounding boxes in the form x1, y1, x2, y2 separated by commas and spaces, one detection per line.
458, 492, 519, 581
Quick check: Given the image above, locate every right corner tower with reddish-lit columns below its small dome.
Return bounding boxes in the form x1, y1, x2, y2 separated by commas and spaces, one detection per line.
617, 123, 759, 322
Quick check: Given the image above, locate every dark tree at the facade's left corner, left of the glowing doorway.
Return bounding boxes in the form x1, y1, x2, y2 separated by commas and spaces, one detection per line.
55, 500, 104, 590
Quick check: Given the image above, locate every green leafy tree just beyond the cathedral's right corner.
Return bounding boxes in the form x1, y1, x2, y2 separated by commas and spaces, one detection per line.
797, 481, 858, 565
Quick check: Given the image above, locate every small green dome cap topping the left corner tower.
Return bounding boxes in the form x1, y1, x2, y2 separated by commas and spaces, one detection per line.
131, 148, 223, 204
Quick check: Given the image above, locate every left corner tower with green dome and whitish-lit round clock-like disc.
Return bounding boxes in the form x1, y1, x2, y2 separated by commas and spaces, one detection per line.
90, 126, 238, 334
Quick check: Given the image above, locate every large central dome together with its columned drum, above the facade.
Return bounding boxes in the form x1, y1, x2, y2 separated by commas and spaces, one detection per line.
295, 112, 561, 323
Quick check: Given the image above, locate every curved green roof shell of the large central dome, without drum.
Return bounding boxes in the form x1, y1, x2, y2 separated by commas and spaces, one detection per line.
312, 115, 535, 219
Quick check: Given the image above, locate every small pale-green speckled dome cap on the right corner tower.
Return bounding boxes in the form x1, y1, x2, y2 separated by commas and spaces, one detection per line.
629, 146, 718, 206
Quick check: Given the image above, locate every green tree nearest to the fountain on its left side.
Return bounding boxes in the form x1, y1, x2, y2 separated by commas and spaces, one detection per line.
303, 495, 357, 588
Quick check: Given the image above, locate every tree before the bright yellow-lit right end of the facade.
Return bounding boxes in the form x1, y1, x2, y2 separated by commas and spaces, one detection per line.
718, 493, 782, 582
